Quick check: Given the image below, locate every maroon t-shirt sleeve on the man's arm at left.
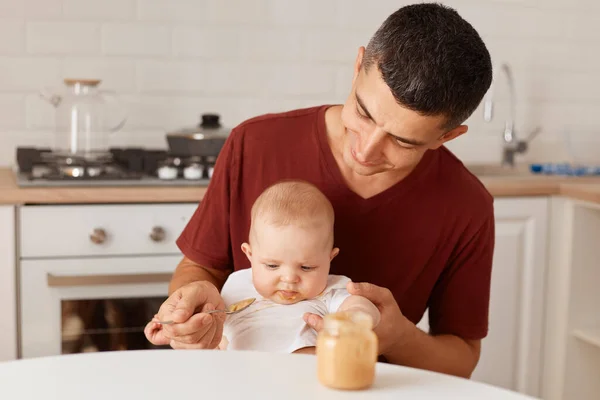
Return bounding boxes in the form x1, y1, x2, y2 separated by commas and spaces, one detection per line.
176, 129, 237, 270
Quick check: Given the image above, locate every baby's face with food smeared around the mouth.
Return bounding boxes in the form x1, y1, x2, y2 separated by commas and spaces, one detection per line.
242, 221, 338, 304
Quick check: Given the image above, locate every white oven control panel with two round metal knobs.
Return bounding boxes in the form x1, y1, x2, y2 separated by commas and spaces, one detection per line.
20, 203, 197, 258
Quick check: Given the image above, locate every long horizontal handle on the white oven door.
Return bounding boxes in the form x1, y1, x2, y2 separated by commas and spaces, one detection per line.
47, 272, 173, 287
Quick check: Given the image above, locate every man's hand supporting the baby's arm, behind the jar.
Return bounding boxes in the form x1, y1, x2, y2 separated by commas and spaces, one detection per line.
304, 282, 410, 355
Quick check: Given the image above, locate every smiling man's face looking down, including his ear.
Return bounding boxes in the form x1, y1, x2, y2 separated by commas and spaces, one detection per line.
342, 48, 467, 176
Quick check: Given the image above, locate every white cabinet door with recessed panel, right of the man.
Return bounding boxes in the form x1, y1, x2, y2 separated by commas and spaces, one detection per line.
418, 197, 549, 396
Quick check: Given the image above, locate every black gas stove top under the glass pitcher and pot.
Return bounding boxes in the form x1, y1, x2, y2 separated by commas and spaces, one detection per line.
15, 147, 216, 187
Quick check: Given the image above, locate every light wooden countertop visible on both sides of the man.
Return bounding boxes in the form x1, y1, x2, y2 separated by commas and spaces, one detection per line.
0, 168, 600, 204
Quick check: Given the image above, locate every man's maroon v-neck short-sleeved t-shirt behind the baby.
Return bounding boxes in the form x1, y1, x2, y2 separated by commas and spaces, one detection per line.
177, 106, 494, 339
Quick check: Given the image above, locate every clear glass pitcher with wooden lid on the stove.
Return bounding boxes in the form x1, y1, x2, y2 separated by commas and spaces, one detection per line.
40, 79, 127, 160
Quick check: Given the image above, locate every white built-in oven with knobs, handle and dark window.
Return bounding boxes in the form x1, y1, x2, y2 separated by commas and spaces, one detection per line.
18, 203, 197, 358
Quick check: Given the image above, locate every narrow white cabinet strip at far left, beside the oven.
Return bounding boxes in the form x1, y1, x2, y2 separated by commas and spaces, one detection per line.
0, 206, 17, 361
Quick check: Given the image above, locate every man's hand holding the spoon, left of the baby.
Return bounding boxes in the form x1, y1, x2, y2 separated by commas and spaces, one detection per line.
144, 281, 225, 349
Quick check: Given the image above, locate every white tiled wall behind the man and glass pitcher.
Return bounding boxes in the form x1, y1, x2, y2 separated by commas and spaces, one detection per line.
0, 0, 600, 165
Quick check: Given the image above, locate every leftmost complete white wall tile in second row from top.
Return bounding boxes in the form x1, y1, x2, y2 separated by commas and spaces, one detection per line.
27, 21, 100, 54
